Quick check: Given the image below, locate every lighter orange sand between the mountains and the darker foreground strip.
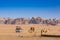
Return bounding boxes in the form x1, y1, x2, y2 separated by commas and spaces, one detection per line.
0, 24, 60, 36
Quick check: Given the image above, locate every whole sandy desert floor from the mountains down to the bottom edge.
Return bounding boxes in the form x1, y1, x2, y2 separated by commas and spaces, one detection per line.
0, 24, 60, 40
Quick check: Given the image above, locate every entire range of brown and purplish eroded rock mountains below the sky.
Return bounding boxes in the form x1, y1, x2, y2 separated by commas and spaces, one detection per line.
0, 17, 60, 25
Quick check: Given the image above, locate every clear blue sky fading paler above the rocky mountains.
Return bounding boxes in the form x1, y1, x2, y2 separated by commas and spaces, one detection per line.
0, 0, 60, 19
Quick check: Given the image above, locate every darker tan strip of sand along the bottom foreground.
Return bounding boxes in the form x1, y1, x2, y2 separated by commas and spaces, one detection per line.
0, 35, 60, 40
